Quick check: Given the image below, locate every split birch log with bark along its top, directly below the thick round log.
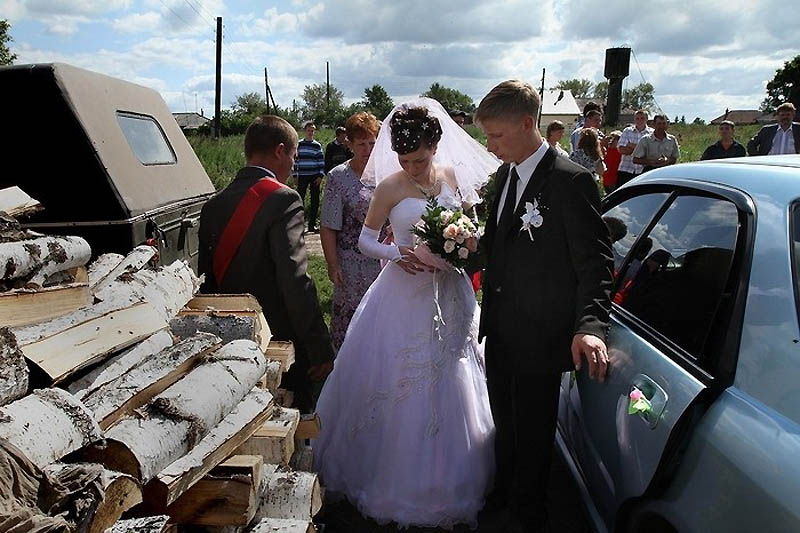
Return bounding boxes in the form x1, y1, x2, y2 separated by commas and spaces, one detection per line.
145, 388, 273, 512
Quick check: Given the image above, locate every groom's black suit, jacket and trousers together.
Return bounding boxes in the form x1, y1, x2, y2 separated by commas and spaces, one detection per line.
480, 148, 613, 527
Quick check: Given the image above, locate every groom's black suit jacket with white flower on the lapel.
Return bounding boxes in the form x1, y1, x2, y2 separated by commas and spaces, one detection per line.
480, 148, 613, 374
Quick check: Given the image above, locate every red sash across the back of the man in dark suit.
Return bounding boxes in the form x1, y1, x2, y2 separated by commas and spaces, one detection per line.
213, 176, 283, 288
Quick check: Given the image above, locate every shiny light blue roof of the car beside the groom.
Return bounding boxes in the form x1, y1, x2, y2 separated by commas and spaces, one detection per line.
630, 155, 800, 203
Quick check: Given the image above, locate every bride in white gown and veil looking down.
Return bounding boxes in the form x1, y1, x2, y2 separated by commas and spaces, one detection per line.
313, 98, 499, 528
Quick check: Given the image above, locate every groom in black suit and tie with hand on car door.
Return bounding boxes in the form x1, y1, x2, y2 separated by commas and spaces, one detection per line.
475, 80, 612, 531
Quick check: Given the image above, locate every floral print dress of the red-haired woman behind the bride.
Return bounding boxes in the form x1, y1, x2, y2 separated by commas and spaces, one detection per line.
321, 161, 381, 351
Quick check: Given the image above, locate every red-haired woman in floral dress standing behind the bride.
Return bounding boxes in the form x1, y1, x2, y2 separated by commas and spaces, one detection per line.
320, 113, 381, 351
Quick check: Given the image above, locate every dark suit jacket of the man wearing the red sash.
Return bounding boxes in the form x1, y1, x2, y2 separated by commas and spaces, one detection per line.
198, 167, 333, 411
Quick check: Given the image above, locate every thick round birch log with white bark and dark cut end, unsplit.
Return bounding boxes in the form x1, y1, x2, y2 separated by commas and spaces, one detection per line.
89, 340, 266, 483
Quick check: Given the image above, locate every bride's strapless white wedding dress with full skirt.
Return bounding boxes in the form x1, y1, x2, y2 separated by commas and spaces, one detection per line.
313, 184, 494, 528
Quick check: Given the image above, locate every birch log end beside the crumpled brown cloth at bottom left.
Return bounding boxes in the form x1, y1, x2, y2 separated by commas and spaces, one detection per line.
43, 463, 142, 533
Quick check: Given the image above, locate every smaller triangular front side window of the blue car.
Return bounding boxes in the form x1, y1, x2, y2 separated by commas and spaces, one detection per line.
603, 192, 669, 276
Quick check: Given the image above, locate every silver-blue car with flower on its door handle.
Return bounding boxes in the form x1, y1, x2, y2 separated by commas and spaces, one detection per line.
557, 156, 800, 532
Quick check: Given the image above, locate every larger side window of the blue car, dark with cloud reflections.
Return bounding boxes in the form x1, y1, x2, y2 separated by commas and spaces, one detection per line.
614, 196, 739, 357
